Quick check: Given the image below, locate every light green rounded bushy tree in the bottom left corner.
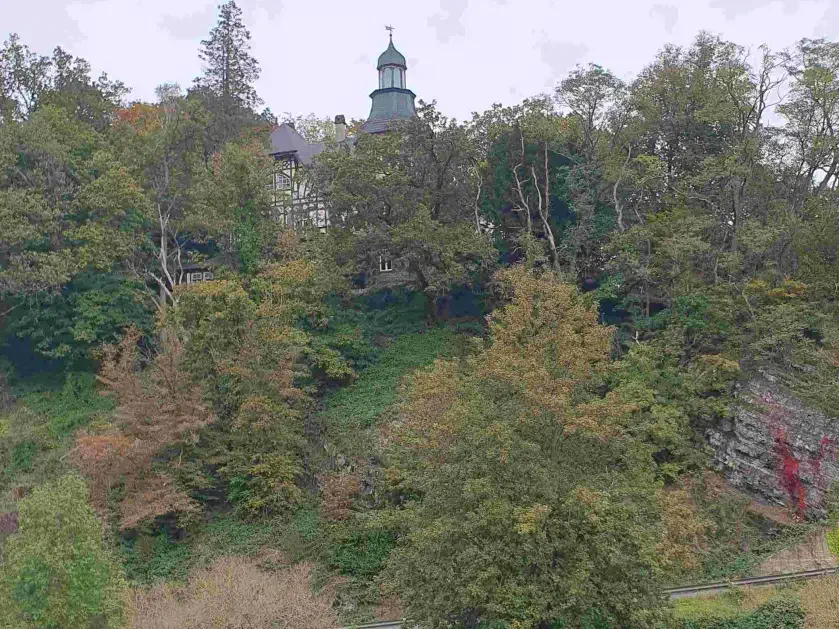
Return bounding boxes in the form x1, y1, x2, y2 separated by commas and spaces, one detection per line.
0, 476, 123, 629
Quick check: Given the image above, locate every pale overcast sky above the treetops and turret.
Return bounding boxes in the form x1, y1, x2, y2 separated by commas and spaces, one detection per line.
0, 0, 839, 119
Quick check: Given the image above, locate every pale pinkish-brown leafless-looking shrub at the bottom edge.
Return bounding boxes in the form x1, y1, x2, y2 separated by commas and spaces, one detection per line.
131, 557, 338, 629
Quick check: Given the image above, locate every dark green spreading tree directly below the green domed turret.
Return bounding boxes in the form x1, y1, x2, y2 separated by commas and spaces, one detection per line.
311, 103, 495, 318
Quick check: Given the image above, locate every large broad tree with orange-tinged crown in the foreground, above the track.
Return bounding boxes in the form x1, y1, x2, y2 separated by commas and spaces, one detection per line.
381, 269, 666, 627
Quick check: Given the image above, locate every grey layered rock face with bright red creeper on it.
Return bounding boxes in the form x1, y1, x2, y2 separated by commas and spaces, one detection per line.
706, 375, 839, 517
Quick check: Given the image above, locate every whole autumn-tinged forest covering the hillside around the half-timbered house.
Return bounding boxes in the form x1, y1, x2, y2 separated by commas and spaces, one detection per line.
0, 0, 839, 629
